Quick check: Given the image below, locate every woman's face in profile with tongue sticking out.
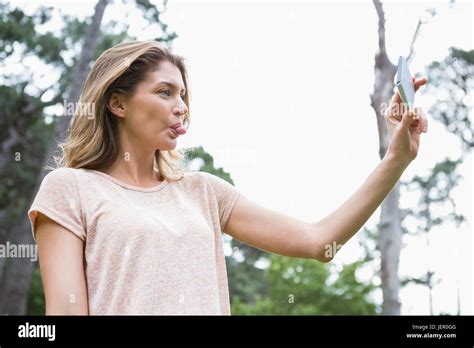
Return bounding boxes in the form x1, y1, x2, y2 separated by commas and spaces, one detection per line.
115, 61, 188, 151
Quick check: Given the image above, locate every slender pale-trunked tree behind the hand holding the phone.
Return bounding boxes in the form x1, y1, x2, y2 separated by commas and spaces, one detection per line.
371, 0, 472, 315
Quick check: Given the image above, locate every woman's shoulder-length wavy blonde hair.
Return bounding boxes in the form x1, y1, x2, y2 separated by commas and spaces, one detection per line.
54, 41, 190, 181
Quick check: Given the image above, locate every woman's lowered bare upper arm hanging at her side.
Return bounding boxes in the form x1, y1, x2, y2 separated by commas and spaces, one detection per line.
36, 213, 88, 315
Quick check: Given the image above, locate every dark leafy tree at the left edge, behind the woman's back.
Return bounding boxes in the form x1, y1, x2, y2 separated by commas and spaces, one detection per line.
0, 0, 176, 314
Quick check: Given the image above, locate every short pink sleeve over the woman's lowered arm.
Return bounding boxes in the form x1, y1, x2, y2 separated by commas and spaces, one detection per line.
28, 168, 86, 241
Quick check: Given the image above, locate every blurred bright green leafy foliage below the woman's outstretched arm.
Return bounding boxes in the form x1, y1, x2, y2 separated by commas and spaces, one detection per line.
232, 254, 380, 315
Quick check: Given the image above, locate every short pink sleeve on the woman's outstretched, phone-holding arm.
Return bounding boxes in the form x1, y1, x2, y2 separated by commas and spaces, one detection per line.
201, 172, 240, 230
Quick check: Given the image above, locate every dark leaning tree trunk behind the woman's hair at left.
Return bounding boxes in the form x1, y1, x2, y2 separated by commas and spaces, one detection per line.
0, 0, 107, 315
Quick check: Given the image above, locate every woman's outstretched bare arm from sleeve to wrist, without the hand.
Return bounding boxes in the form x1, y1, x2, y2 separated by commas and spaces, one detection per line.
225, 157, 408, 262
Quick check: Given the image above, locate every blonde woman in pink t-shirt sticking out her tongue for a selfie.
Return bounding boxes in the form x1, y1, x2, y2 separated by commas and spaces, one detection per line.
28, 42, 427, 314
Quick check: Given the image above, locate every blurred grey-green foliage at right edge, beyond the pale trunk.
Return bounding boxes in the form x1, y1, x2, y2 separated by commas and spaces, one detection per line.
402, 48, 474, 314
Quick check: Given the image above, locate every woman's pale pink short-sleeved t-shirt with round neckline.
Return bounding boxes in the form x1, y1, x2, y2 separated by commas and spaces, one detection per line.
28, 168, 239, 315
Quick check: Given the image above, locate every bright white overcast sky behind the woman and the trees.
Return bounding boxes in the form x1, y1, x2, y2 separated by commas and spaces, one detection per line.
12, 1, 474, 314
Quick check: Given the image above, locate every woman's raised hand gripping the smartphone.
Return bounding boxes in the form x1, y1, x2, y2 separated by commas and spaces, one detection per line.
384, 78, 428, 164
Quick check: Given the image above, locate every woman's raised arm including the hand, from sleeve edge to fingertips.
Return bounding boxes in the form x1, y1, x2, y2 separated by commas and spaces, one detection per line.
225, 79, 427, 262
